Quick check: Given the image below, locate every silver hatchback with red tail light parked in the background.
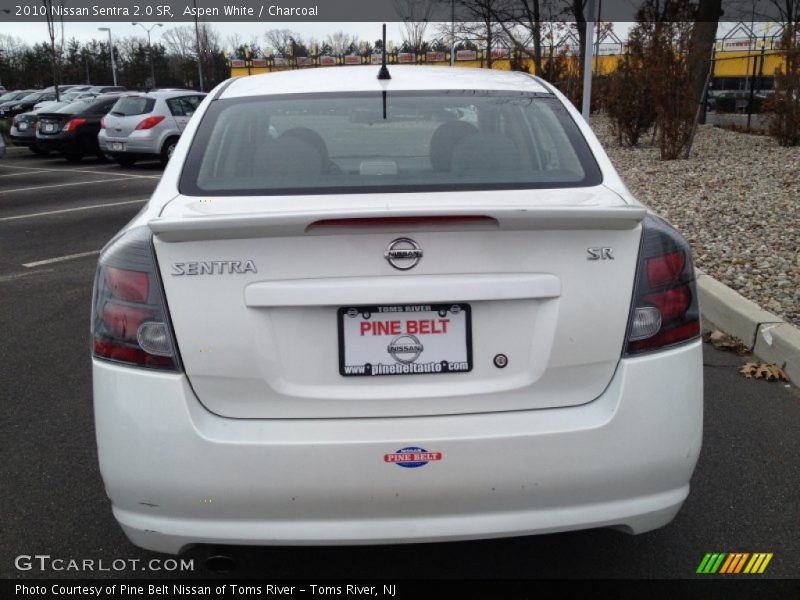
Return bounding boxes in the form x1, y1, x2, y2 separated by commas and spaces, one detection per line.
97, 90, 205, 166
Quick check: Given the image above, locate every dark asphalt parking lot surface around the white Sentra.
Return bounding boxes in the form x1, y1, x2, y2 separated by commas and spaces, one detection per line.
0, 143, 800, 578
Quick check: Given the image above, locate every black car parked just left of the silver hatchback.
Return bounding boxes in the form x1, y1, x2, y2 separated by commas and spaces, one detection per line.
36, 95, 119, 162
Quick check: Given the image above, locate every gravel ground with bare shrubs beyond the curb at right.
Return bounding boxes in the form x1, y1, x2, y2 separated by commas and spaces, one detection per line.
592, 117, 800, 326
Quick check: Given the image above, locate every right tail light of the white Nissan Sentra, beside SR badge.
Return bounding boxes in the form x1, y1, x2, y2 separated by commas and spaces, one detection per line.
625, 215, 700, 356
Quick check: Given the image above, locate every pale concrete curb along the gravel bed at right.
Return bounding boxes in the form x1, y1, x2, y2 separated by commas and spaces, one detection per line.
695, 269, 800, 385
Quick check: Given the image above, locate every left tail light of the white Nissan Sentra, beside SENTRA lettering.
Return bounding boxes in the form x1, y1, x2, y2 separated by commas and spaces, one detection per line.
92, 227, 179, 371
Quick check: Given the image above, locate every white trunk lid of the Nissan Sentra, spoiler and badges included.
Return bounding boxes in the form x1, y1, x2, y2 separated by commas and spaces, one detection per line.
150, 186, 645, 418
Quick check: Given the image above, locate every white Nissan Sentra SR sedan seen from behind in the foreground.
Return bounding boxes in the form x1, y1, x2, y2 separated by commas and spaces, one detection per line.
92, 66, 703, 553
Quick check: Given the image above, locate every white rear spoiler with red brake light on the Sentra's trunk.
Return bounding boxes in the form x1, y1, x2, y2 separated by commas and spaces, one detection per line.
148, 206, 647, 243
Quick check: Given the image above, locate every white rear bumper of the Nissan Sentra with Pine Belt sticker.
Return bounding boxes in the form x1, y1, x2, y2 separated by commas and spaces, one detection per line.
94, 341, 703, 553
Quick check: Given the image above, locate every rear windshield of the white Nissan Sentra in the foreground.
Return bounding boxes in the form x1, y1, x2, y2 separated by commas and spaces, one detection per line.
180, 91, 601, 196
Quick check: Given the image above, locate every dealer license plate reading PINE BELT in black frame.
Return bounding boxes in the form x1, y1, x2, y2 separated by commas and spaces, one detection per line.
338, 303, 472, 377
